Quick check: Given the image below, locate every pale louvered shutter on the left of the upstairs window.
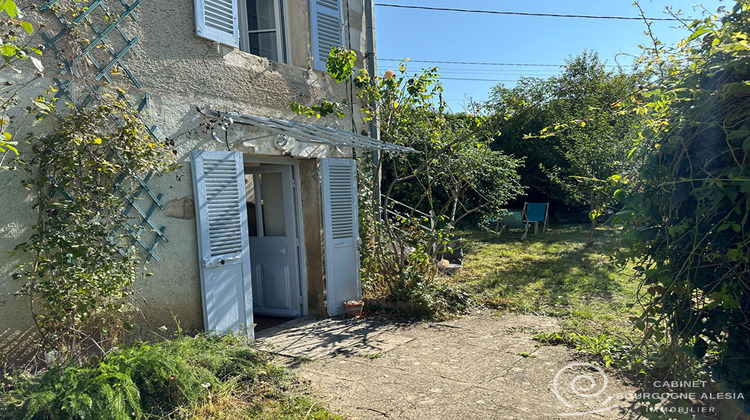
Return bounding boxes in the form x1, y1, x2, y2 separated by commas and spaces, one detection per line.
195, 0, 240, 48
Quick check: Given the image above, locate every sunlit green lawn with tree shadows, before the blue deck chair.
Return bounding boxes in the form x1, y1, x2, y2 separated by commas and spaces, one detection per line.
448, 225, 639, 336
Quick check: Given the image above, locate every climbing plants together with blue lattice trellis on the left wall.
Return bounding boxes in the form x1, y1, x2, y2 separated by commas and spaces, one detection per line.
0, 0, 177, 355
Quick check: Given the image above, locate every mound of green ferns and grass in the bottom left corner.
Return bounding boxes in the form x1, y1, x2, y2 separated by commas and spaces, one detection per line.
0, 336, 338, 420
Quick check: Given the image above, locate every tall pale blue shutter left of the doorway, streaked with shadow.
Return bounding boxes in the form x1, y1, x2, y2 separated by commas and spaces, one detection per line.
190, 150, 253, 338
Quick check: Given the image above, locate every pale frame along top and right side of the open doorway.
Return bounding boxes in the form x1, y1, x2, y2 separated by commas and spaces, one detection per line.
242, 153, 308, 316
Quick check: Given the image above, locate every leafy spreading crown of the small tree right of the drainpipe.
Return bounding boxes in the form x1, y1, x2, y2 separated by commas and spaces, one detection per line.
382, 110, 523, 226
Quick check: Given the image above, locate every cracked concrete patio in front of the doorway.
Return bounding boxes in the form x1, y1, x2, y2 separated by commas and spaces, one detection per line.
261, 313, 635, 420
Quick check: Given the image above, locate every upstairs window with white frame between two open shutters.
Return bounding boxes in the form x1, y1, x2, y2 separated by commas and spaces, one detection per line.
240, 0, 287, 62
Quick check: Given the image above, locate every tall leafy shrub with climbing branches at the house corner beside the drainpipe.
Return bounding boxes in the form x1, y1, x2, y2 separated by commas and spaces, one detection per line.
291, 53, 522, 314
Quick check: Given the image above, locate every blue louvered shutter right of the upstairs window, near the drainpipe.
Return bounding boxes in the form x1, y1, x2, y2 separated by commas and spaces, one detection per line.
310, 0, 344, 71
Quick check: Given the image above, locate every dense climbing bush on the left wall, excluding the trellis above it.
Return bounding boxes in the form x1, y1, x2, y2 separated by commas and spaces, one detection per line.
15, 99, 175, 351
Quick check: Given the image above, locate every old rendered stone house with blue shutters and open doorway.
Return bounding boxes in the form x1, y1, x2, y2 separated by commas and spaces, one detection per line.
0, 0, 403, 357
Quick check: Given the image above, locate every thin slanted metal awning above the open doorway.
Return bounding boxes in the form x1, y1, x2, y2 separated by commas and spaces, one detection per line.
214, 111, 419, 153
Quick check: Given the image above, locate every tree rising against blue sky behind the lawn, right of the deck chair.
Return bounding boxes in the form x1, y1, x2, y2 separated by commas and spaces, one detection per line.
490, 52, 643, 246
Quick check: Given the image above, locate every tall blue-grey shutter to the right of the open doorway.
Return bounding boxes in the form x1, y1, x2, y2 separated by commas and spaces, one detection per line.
321, 159, 362, 316
